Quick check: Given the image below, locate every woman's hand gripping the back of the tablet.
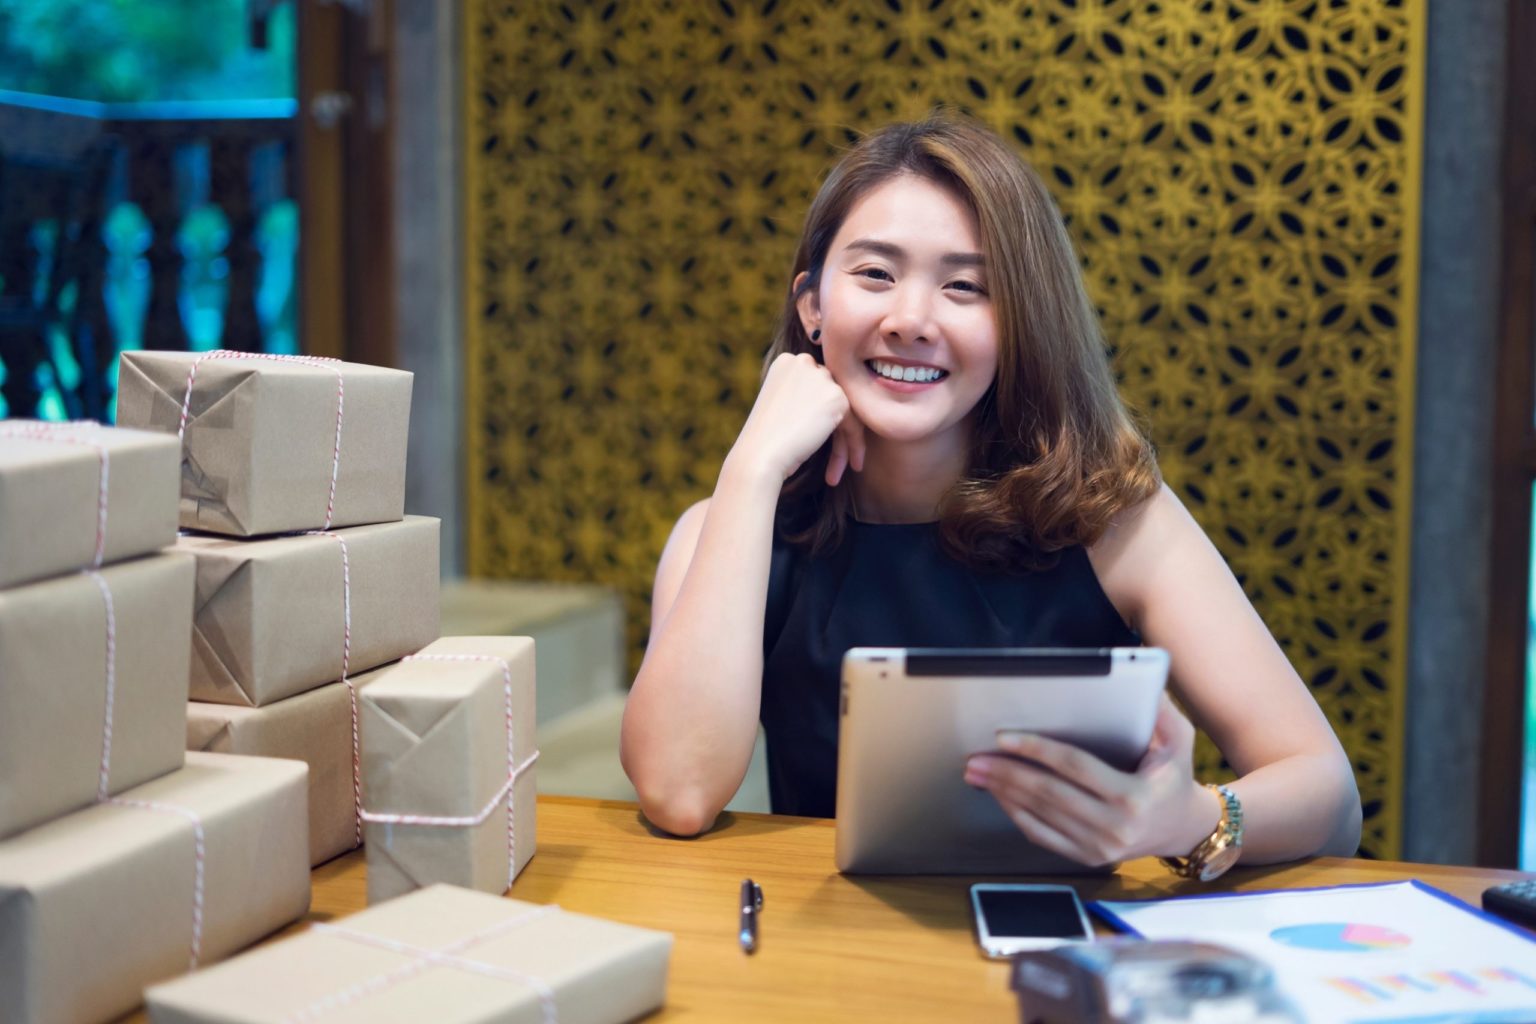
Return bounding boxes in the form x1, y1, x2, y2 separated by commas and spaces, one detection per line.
965, 694, 1221, 866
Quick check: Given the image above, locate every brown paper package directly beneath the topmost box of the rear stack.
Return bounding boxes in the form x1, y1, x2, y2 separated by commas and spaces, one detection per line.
177, 516, 441, 708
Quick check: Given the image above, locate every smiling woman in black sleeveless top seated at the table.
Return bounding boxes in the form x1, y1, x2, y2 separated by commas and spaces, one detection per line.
621, 117, 1361, 874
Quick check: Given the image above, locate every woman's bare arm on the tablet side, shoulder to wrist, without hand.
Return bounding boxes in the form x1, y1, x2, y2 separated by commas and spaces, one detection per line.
1089, 487, 1361, 864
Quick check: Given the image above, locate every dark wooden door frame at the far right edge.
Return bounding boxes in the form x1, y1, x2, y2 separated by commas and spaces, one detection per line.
1474, 0, 1536, 867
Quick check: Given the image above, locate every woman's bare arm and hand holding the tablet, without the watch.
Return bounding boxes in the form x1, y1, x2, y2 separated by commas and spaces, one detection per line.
965, 487, 1361, 864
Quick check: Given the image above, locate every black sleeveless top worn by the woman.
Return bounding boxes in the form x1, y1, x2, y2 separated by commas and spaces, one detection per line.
762, 520, 1141, 818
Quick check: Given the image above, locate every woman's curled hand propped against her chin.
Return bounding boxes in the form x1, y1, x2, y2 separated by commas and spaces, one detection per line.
730, 352, 865, 487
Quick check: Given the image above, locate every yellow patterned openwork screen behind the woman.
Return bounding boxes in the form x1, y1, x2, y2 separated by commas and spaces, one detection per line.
465, 0, 1424, 855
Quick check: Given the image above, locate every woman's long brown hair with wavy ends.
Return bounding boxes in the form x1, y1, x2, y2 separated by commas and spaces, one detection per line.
763, 112, 1161, 571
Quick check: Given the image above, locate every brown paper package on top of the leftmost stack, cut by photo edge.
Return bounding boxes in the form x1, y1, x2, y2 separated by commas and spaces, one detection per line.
0, 419, 180, 586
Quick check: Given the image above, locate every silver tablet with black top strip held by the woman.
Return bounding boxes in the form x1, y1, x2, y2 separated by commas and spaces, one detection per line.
837, 648, 1167, 875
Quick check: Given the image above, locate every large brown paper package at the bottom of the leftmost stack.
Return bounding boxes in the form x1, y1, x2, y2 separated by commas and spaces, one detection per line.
0, 754, 309, 1024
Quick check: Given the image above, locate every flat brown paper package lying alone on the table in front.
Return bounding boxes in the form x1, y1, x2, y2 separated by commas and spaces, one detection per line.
144, 886, 673, 1024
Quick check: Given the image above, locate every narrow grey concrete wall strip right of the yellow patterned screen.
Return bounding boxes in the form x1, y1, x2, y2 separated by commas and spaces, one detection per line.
1402, 0, 1521, 864
